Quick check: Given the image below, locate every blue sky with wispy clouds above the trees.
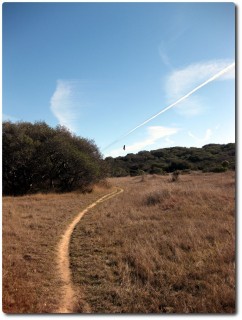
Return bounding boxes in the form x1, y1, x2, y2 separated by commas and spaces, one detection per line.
2, 2, 235, 156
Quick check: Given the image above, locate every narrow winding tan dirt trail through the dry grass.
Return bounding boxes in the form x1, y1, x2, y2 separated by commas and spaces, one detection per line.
57, 188, 123, 313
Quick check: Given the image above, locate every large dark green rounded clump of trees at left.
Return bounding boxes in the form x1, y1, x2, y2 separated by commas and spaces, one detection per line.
2, 122, 107, 195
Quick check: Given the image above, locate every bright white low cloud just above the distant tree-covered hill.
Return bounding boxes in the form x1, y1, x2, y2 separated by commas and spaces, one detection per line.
107, 126, 179, 157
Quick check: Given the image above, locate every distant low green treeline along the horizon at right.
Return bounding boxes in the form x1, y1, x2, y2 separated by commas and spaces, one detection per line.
105, 143, 235, 177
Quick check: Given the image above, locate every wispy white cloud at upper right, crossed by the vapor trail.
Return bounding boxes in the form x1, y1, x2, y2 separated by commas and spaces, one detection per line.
165, 60, 235, 116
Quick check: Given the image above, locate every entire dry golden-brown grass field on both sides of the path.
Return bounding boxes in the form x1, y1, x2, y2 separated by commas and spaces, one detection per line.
3, 172, 235, 313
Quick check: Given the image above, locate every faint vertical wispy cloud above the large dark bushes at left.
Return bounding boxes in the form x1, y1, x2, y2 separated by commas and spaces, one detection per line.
50, 80, 80, 131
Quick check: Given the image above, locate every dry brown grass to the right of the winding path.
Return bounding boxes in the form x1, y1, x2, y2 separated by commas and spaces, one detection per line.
70, 172, 235, 313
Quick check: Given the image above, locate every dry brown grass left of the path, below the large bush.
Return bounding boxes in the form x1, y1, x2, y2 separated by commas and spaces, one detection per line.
2, 185, 110, 313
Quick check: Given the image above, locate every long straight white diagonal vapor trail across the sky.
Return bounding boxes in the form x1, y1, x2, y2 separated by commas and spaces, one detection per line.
102, 62, 235, 151
